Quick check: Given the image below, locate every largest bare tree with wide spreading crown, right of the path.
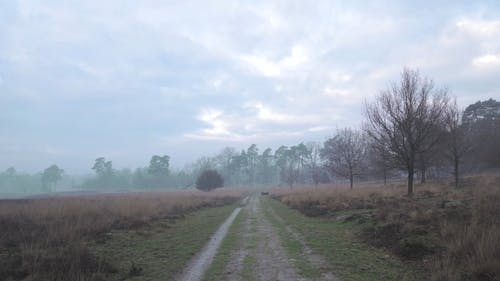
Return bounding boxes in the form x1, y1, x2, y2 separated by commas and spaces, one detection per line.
365, 69, 449, 196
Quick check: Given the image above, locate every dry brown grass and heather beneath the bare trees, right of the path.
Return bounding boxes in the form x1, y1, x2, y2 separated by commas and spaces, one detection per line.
272, 176, 500, 281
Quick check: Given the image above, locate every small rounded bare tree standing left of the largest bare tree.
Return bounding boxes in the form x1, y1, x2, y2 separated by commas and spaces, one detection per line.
321, 128, 367, 189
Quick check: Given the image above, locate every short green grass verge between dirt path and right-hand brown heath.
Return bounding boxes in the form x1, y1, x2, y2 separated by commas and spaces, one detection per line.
263, 199, 426, 281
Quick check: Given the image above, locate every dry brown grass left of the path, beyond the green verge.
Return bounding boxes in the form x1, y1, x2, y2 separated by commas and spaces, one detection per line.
0, 189, 243, 280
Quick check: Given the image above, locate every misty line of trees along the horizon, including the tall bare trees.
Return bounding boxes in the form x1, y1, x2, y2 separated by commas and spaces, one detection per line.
0, 69, 500, 195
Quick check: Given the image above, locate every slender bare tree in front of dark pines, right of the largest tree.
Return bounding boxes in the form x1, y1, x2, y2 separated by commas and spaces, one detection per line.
445, 101, 471, 187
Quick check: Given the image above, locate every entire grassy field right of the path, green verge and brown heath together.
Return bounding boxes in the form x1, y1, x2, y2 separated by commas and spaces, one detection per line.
272, 176, 500, 281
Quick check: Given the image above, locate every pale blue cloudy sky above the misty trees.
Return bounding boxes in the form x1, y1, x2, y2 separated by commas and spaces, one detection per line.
0, 0, 500, 173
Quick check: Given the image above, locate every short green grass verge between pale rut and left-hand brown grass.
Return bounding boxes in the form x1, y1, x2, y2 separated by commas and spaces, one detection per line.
90, 205, 235, 281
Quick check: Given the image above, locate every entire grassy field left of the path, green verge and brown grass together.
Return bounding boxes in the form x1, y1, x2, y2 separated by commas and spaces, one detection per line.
0, 189, 243, 280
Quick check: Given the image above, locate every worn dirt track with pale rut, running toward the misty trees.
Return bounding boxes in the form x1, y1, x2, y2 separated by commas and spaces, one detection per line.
178, 194, 340, 281
